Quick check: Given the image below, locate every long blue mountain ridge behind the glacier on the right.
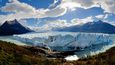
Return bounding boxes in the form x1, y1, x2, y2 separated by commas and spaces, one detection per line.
55, 20, 115, 34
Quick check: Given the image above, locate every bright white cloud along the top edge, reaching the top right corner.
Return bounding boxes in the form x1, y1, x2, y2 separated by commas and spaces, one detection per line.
61, 0, 115, 14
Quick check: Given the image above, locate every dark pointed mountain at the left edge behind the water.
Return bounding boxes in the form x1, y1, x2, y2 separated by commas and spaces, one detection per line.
0, 19, 32, 36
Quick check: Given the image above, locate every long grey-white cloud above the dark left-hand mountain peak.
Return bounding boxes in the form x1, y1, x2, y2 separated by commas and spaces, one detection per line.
0, 0, 67, 22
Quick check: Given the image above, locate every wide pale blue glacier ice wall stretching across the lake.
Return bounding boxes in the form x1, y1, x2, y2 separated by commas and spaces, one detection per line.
14, 33, 113, 51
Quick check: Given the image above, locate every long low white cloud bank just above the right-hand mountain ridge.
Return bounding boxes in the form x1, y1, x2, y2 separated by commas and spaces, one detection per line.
45, 16, 93, 27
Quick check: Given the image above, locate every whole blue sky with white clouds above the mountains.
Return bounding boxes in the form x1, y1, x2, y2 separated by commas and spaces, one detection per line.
0, 0, 115, 30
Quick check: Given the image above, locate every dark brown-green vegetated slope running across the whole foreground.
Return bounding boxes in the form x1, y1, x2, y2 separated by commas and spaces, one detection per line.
0, 41, 115, 65
